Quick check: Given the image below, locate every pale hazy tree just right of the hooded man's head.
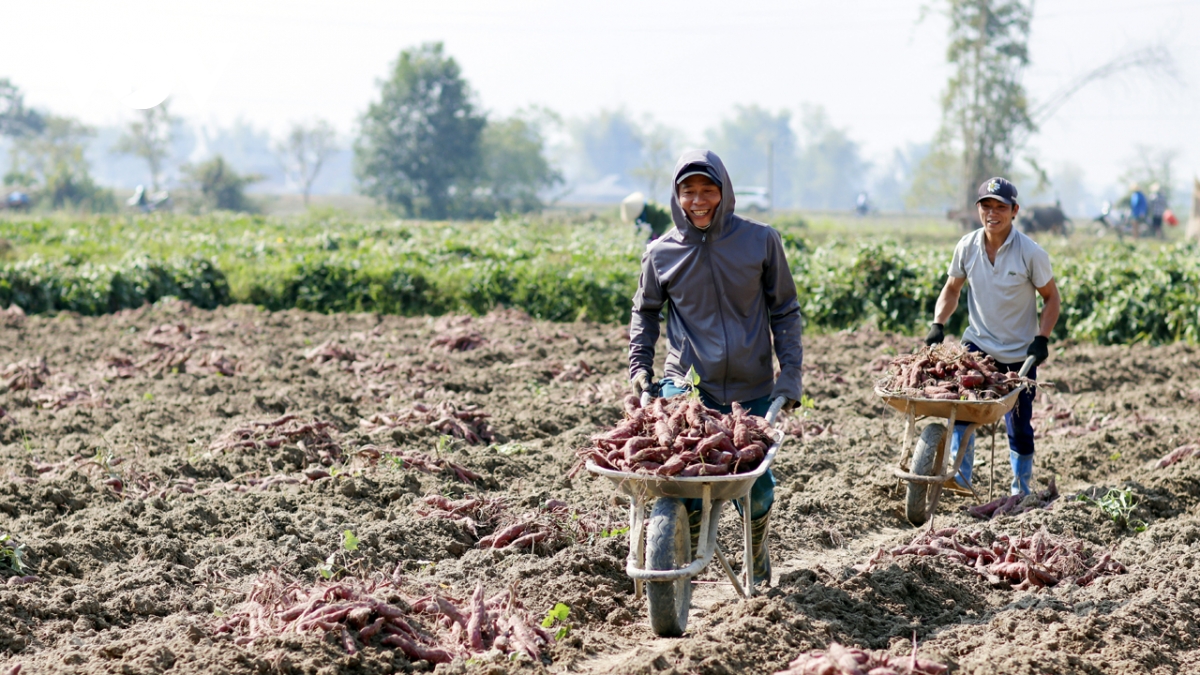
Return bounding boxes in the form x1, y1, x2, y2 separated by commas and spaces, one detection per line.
704, 106, 797, 207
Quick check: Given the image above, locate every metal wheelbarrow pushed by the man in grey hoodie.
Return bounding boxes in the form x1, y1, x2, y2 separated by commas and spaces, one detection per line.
586, 393, 784, 638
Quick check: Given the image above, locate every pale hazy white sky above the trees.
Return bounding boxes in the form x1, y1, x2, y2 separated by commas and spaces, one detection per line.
0, 0, 1200, 194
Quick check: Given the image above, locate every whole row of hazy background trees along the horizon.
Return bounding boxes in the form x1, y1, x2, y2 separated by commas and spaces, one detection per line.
0, 0, 1171, 219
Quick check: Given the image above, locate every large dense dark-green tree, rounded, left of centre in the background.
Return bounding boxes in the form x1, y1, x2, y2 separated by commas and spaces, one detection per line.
354, 42, 486, 219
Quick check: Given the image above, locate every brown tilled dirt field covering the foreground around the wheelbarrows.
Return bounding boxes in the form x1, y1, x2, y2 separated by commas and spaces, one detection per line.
0, 304, 1200, 675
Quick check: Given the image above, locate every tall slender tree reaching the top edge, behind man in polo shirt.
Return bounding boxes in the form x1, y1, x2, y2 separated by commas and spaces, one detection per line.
916, 0, 1037, 210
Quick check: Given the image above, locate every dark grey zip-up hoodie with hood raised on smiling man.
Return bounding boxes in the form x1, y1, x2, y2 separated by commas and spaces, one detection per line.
629, 150, 804, 405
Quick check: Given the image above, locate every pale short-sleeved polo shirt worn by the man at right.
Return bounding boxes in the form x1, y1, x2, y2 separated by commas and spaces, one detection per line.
947, 227, 1054, 363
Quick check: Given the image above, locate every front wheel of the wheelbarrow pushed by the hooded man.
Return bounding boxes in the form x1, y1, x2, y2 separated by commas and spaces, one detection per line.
646, 497, 691, 638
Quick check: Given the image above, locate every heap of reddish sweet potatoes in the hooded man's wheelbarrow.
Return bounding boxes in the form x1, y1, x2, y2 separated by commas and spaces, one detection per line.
578, 396, 774, 477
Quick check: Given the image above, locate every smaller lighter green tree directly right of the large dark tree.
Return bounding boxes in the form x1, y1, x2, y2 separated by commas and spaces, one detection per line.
482, 115, 563, 213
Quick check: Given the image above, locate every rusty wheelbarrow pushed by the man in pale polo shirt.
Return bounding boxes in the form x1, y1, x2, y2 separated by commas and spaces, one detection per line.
875, 357, 1034, 526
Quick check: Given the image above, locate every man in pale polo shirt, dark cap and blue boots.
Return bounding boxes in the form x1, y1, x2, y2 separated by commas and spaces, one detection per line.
925, 178, 1061, 495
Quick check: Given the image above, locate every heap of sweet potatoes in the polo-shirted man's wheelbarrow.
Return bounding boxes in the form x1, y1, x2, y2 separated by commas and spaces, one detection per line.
878, 344, 1020, 401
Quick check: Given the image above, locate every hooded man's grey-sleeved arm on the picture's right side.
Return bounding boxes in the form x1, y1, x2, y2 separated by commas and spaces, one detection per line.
762, 229, 804, 401
